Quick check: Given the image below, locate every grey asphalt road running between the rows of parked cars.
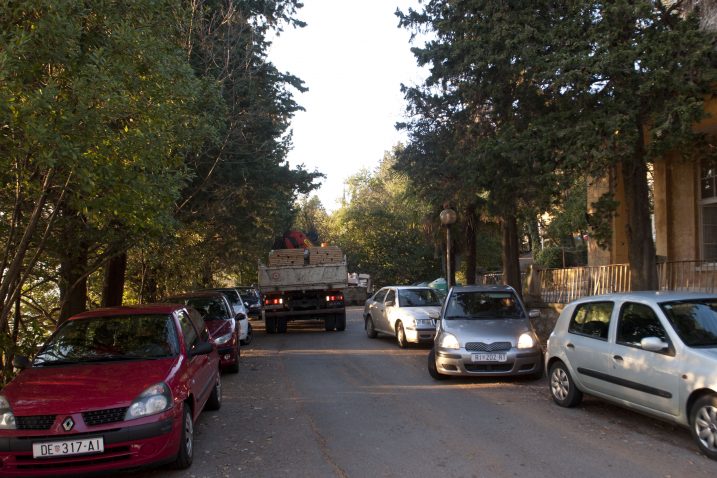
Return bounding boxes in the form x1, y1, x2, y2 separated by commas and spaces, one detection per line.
130, 307, 717, 478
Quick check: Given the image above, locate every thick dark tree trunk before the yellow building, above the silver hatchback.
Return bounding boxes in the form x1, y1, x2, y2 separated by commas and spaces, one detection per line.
622, 155, 659, 290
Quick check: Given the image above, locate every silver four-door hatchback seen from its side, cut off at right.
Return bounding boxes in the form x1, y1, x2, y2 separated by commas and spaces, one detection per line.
546, 292, 717, 459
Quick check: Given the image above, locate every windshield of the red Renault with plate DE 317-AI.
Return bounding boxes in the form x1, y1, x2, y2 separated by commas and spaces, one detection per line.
33, 314, 179, 366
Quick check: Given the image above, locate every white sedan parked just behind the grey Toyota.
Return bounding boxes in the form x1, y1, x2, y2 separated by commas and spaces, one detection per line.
363, 286, 441, 348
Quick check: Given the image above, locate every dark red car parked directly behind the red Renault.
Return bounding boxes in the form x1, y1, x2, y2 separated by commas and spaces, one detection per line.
164, 291, 241, 373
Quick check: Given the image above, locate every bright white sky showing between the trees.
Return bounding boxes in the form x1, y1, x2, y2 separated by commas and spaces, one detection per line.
269, 0, 425, 211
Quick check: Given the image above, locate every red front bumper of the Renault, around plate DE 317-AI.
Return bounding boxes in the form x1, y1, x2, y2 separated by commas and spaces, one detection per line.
0, 414, 182, 477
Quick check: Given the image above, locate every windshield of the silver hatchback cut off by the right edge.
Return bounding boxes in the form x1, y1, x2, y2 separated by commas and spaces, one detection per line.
660, 299, 717, 347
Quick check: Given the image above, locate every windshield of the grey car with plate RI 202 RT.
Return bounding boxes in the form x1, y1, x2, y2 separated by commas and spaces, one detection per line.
445, 291, 524, 320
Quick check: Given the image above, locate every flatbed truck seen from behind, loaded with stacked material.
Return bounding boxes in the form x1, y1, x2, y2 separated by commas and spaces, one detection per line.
258, 246, 348, 334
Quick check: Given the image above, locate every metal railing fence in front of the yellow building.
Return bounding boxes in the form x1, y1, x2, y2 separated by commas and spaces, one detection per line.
477, 261, 717, 304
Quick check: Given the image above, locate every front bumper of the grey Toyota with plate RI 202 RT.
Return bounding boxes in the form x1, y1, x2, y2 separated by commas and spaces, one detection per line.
436, 349, 543, 376
